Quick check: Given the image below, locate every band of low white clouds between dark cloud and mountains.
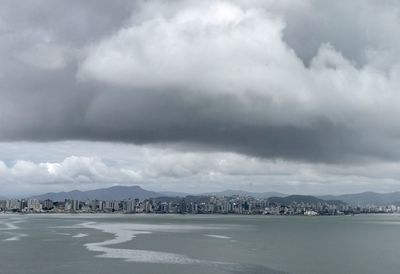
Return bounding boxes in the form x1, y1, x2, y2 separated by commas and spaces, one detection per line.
0, 142, 400, 195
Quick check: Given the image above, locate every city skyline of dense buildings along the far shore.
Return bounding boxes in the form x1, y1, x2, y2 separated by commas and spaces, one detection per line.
0, 188, 400, 216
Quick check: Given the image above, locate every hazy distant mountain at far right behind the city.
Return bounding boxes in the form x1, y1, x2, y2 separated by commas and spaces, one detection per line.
319, 192, 400, 206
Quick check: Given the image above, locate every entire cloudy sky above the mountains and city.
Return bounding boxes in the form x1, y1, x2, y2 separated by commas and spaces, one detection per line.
0, 0, 400, 196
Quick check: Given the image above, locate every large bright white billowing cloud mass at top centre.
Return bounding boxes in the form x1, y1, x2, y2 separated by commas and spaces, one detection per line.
79, 2, 300, 92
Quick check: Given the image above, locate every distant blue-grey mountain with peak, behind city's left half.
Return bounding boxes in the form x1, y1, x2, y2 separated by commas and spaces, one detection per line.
30, 186, 163, 201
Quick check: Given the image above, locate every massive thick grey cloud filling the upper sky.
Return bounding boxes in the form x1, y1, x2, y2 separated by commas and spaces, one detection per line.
0, 0, 400, 166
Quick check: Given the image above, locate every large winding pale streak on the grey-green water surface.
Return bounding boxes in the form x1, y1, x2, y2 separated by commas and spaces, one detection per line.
49, 217, 284, 274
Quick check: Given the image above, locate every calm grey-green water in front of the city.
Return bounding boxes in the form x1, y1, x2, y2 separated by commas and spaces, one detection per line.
0, 214, 400, 274
